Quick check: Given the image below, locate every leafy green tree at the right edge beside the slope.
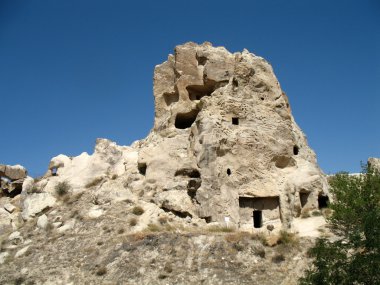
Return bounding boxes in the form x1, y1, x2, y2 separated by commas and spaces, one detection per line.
300, 167, 380, 285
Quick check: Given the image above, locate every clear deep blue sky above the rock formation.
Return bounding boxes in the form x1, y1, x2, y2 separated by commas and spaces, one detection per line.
0, 0, 380, 176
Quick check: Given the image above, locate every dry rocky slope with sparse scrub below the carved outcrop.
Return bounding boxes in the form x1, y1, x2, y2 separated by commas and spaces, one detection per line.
0, 185, 330, 284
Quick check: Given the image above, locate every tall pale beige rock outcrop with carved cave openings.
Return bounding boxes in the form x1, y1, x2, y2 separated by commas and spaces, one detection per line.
16, 43, 328, 228
